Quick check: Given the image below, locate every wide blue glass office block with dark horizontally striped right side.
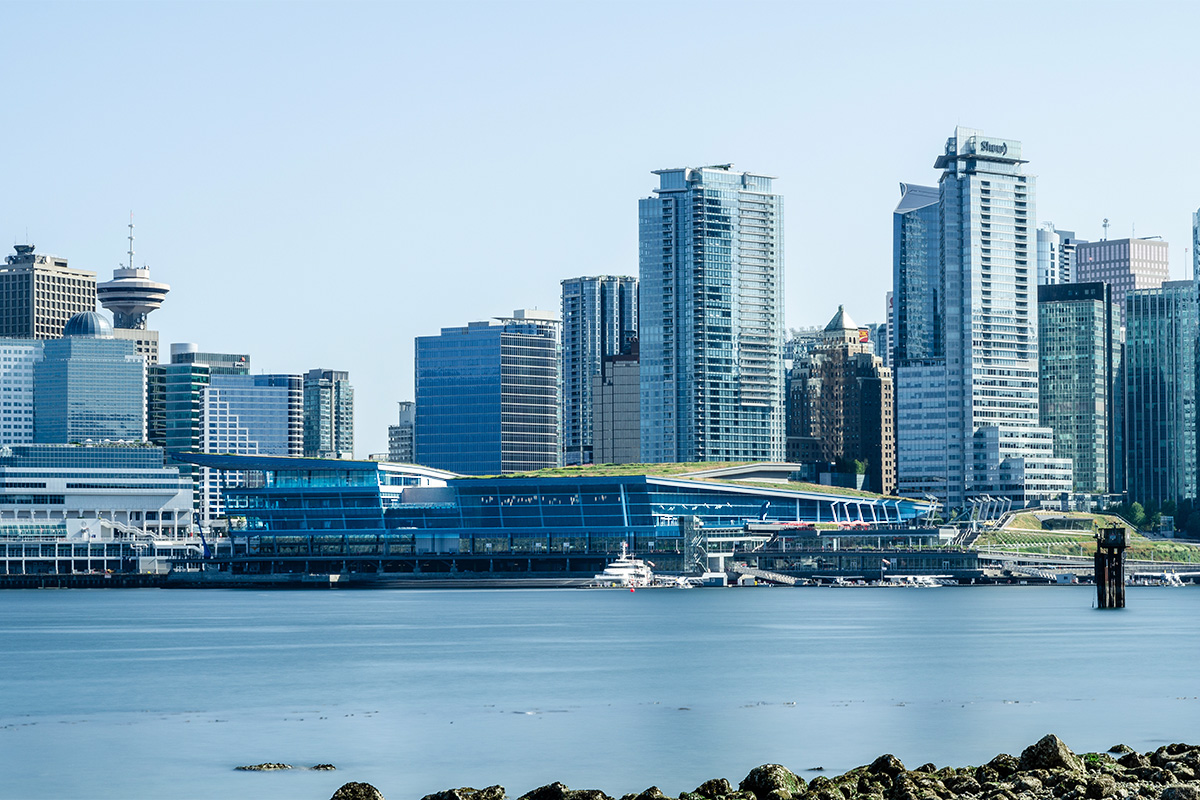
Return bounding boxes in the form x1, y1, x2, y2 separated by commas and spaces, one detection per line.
415, 309, 562, 475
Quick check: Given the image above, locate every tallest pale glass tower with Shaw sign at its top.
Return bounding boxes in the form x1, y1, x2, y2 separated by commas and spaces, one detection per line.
896, 127, 1072, 507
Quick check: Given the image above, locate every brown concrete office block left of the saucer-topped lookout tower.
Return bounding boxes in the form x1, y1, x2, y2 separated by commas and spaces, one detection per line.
0, 245, 96, 339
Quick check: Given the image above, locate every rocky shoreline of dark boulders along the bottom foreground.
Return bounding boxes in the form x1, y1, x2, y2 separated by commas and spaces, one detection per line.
319, 734, 1200, 800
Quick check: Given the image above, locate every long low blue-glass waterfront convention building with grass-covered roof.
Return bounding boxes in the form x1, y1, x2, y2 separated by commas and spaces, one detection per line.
188, 453, 953, 576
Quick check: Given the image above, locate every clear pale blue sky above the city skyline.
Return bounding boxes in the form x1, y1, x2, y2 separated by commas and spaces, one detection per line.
0, 1, 1200, 456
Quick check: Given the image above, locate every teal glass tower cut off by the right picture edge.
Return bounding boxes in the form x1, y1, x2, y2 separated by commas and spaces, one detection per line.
1128, 281, 1200, 504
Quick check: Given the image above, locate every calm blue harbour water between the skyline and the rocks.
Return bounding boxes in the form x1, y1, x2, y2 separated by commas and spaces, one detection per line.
0, 587, 1200, 800
